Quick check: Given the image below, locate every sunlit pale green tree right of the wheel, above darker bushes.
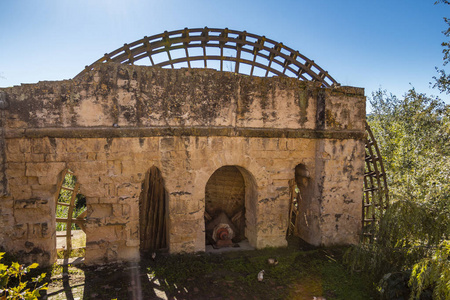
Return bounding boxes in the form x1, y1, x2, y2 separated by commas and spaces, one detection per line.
368, 89, 450, 216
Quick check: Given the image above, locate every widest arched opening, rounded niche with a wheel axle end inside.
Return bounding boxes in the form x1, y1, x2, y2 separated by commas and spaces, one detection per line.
205, 166, 256, 249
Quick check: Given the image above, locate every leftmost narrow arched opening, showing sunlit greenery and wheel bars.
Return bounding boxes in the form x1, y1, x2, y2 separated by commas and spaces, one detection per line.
56, 169, 87, 258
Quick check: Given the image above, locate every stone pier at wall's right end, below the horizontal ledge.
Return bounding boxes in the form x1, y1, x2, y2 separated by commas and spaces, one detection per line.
320, 140, 364, 246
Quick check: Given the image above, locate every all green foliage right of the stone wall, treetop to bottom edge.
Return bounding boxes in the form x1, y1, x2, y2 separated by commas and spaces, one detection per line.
346, 89, 450, 299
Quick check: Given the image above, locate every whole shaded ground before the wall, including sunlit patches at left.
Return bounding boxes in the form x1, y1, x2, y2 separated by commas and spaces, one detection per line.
44, 239, 375, 300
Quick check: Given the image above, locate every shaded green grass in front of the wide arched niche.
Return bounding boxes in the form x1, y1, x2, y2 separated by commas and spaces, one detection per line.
147, 249, 376, 299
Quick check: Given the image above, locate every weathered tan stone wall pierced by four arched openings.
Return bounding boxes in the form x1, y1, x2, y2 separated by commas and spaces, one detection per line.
0, 64, 365, 263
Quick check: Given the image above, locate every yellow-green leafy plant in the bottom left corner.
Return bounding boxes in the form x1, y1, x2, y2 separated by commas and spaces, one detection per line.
0, 252, 47, 300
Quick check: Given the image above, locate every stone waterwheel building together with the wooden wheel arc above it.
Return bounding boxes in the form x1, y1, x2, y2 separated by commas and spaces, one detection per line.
0, 28, 386, 265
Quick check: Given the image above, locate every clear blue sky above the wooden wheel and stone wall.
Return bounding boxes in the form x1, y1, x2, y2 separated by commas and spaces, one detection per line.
0, 0, 450, 108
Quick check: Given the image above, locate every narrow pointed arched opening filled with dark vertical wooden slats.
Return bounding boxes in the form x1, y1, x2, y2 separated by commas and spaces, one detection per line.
139, 166, 167, 254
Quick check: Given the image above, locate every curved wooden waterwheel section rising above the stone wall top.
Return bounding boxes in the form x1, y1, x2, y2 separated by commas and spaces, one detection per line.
75, 27, 339, 87
